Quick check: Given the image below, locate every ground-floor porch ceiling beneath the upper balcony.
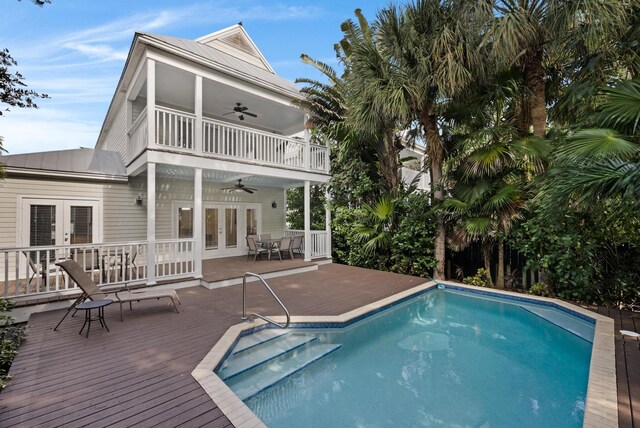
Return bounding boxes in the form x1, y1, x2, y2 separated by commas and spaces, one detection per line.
154, 164, 304, 189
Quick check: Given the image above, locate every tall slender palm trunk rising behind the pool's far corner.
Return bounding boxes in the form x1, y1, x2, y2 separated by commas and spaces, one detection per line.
420, 111, 446, 279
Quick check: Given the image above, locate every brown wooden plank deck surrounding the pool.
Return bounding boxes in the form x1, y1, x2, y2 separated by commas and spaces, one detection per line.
0, 260, 640, 428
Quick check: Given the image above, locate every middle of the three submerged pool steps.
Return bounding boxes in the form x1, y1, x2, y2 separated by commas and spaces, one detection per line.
218, 334, 316, 380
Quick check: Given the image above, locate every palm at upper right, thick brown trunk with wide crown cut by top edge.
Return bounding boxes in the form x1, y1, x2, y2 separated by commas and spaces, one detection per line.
485, 0, 633, 137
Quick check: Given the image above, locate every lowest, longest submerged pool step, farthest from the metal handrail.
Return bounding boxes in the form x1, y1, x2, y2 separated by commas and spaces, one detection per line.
225, 342, 342, 400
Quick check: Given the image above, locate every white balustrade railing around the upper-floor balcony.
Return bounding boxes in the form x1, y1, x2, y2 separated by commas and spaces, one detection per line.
128, 106, 329, 173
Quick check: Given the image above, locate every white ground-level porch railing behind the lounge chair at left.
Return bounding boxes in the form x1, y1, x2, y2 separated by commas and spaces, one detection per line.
0, 239, 195, 298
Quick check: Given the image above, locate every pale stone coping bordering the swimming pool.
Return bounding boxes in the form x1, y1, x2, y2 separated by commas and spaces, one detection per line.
191, 281, 618, 428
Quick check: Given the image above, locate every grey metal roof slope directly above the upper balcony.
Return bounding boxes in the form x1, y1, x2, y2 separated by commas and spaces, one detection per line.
137, 30, 299, 96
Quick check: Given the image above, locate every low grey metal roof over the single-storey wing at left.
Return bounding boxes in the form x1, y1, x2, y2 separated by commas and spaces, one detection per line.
0, 148, 127, 178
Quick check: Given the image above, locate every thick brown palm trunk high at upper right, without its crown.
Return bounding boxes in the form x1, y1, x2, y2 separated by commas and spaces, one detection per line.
521, 46, 547, 137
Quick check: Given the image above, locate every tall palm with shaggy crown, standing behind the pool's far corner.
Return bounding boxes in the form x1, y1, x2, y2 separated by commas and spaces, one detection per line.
377, 0, 481, 278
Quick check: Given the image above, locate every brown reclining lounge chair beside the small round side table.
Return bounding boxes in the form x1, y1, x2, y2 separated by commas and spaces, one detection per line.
54, 260, 182, 330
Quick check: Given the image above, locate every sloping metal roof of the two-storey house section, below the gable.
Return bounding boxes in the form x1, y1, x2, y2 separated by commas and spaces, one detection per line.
139, 33, 299, 94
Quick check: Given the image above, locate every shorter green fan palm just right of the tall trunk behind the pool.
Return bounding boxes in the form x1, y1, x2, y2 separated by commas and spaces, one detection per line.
444, 73, 548, 288
